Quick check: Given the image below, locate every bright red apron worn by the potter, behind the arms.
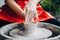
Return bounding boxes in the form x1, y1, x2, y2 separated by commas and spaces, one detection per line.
0, 0, 53, 22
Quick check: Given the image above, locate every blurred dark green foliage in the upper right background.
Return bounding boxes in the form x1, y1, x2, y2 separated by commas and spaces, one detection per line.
39, 0, 60, 19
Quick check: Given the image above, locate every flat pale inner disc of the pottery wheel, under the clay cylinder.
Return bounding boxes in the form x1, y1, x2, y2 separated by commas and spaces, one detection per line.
10, 28, 52, 40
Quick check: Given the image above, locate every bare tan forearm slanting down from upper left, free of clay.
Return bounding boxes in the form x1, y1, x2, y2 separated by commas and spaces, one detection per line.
6, 0, 25, 17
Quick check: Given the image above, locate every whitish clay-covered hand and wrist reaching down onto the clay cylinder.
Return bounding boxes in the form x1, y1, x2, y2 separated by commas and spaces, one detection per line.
24, 0, 40, 22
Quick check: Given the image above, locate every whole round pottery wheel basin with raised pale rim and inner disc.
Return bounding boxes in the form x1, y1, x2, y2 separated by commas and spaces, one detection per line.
0, 22, 60, 40
